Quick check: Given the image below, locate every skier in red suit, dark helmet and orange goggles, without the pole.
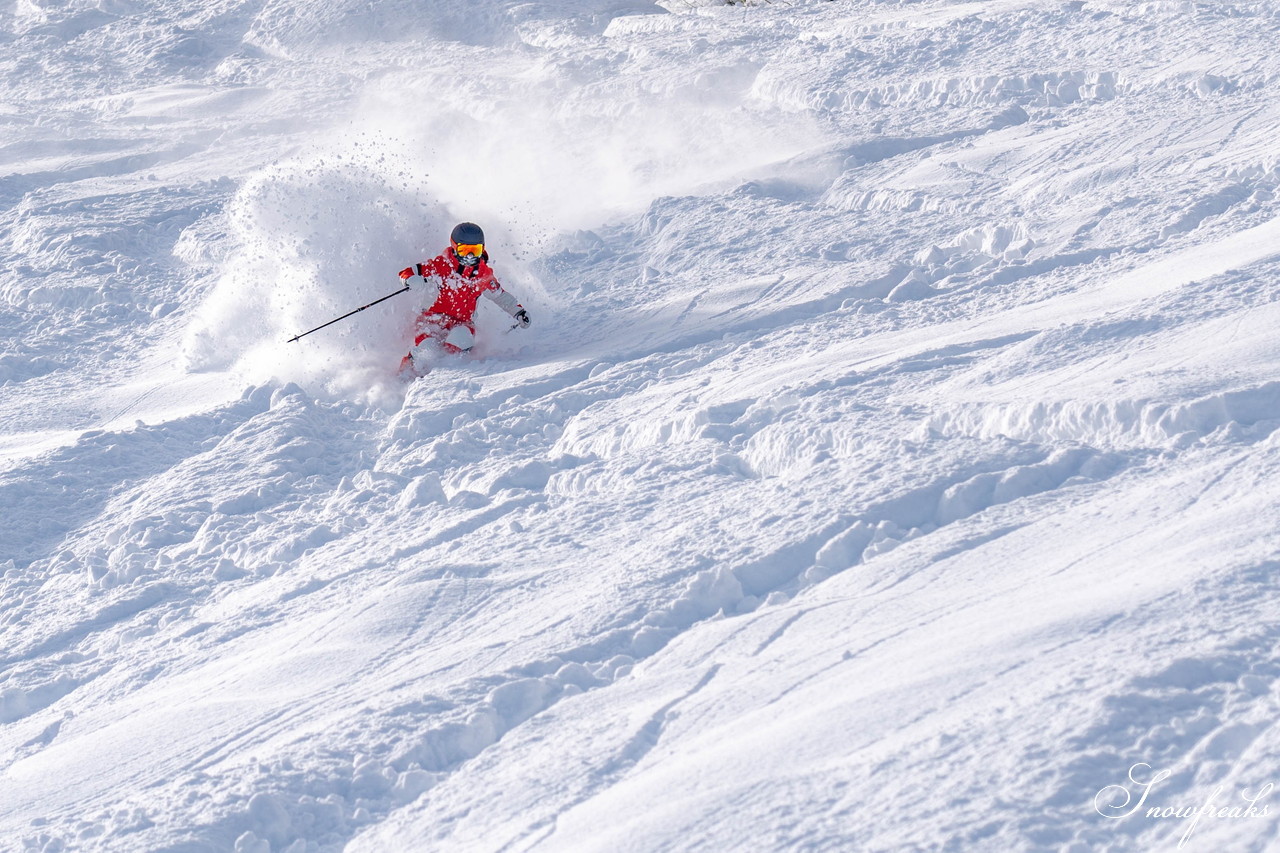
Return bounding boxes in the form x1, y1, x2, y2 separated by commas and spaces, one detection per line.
401, 222, 529, 374
